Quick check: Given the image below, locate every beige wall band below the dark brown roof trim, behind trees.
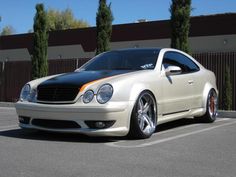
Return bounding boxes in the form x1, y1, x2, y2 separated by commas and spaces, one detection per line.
0, 34, 236, 61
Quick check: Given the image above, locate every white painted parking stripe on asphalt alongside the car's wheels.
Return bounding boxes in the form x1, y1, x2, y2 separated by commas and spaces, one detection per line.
105, 118, 236, 148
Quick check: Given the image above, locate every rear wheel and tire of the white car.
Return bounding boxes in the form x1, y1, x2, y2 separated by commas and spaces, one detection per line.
199, 89, 218, 123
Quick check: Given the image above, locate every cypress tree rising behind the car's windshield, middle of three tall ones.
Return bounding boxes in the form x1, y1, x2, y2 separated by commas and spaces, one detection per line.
96, 0, 113, 54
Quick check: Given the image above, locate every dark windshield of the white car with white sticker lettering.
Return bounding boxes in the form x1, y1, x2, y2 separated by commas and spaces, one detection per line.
80, 49, 159, 71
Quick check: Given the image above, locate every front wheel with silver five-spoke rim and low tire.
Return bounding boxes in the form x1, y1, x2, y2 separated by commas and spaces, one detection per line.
129, 91, 157, 139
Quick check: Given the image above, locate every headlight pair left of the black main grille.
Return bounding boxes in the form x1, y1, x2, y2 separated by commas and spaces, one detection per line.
20, 84, 37, 102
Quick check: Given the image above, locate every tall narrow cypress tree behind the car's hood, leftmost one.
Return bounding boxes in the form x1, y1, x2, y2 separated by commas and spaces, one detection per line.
32, 4, 48, 79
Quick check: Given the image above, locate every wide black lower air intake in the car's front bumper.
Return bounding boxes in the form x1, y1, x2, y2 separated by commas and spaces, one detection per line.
32, 119, 81, 129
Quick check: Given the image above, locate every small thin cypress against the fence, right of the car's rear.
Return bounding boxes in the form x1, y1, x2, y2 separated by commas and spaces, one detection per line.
223, 66, 232, 110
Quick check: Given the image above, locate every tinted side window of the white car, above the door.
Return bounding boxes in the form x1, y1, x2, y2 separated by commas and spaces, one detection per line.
162, 52, 199, 74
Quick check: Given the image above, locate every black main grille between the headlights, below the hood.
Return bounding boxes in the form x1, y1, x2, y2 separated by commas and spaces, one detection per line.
37, 86, 79, 102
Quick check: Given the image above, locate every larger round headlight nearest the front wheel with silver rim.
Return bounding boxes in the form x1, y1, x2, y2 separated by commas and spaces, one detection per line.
97, 84, 113, 104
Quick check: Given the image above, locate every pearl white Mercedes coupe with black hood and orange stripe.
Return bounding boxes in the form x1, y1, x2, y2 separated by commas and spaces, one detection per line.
15, 48, 218, 138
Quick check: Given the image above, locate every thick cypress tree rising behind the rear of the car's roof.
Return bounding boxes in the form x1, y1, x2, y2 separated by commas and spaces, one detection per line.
170, 0, 191, 53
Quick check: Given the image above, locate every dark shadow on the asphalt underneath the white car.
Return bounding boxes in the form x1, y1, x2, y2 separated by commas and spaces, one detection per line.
0, 118, 199, 143
